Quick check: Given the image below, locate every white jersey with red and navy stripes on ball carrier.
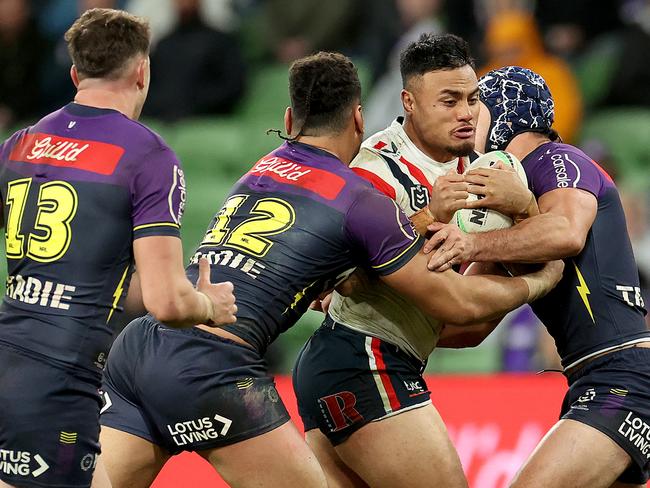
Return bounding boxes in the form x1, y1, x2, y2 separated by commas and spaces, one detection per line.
329, 117, 474, 361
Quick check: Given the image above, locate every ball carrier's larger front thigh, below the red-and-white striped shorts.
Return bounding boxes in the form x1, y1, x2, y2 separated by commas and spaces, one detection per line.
336, 405, 467, 488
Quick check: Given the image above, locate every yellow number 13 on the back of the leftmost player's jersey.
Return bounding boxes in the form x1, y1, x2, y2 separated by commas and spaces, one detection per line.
5, 178, 79, 263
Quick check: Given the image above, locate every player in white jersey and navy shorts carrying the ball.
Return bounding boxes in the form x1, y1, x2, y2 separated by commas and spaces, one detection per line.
294, 34, 531, 488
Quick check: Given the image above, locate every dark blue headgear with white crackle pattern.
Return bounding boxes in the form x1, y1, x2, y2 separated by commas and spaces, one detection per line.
478, 66, 554, 151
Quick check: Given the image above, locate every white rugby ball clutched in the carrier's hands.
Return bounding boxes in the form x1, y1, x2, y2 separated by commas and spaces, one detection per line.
452, 151, 528, 232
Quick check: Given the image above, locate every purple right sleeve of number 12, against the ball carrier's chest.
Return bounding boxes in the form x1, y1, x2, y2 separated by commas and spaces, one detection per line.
345, 189, 424, 275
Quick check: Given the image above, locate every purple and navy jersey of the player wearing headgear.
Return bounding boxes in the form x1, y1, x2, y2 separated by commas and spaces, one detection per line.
522, 142, 650, 368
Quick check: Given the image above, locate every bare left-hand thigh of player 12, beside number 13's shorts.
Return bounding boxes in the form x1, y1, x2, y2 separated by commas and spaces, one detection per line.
100, 426, 170, 488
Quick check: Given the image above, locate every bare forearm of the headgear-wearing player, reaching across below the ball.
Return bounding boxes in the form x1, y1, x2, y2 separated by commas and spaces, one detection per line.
470, 214, 575, 263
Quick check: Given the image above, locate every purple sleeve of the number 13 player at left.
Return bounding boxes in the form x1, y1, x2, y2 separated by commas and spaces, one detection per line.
131, 146, 186, 239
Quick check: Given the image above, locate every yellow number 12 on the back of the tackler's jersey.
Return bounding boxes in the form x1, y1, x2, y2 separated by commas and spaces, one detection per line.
202, 195, 296, 257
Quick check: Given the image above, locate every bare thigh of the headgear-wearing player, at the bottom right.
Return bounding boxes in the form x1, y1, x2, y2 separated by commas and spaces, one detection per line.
511, 419, 631, 488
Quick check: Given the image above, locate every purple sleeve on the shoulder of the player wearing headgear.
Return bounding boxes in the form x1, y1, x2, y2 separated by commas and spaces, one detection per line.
526, 150, 604, 198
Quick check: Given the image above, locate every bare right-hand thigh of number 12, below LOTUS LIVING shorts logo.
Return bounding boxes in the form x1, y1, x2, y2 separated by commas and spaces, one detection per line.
199, 422, 327, 488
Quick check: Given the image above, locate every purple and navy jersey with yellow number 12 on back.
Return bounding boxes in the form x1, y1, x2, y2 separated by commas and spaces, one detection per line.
188, 142, 423, 351
